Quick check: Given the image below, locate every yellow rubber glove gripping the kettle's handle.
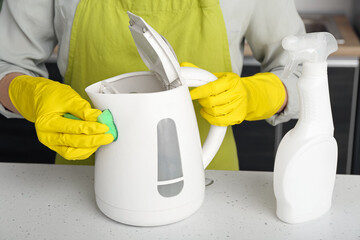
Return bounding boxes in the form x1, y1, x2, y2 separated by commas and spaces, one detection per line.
181, 63, 286, 126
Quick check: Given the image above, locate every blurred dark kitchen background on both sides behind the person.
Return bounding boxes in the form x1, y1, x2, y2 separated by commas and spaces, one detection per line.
0, 0, 360, 174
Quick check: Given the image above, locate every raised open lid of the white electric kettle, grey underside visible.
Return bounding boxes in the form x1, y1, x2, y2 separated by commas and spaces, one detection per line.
127, 11, 182, 89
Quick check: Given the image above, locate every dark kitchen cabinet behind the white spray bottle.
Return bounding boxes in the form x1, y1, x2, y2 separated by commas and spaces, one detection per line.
233, 59, 360, 174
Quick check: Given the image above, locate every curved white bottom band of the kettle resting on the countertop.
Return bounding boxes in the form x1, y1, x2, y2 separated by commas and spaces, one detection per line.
96, 196, 204, 227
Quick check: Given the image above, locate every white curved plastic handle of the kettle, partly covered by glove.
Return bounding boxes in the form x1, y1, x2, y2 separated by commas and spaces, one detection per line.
180, 67, 227, 168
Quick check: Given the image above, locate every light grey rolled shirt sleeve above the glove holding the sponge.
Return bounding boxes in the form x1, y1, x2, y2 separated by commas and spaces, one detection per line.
0, 0, 57, 117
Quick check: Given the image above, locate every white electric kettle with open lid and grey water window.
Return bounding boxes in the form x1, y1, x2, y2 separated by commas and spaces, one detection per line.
85, 12, 226, 226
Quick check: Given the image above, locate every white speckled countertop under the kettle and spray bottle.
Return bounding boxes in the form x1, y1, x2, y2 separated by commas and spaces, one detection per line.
0, 163, 360, 240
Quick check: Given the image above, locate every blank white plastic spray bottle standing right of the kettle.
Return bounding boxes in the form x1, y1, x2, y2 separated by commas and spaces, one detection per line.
274, 32, 337, 224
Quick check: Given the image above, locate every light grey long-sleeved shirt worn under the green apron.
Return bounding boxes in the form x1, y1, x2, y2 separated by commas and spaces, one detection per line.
0, 0, 305, 125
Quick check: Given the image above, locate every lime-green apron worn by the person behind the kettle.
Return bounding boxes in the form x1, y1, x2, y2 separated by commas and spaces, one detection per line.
56, 0, 239, 170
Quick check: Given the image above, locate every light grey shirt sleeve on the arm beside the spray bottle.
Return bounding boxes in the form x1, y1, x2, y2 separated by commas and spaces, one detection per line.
245, 0, 305, 125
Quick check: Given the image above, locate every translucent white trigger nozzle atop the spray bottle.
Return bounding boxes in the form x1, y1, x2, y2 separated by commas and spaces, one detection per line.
282, 32, 338, 79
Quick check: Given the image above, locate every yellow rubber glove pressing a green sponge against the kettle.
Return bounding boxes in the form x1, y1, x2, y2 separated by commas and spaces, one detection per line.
9, 75, 114, 160
